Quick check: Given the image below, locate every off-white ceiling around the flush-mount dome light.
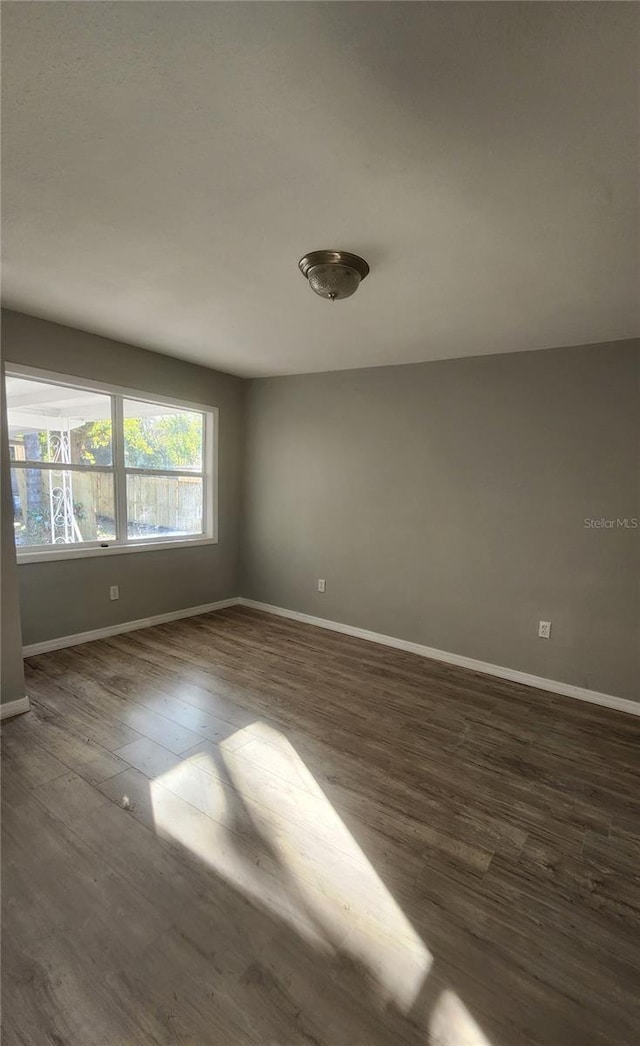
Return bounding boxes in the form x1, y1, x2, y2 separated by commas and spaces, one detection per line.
2, 2, 640, 374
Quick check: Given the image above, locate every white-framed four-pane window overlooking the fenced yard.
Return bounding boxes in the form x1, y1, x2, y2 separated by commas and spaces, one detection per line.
6, 367, 218, 561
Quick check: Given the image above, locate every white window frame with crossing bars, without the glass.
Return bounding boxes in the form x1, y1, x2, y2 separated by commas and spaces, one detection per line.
4, 362, 219, 564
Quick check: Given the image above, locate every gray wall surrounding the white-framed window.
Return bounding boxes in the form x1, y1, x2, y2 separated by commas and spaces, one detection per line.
2, 311, 245, 643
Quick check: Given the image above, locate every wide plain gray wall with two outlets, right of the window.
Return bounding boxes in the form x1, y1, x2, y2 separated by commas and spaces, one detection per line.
242, 342, 640, 699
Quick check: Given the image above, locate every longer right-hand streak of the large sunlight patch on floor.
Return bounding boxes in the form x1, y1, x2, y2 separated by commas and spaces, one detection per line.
221, 723, 432, 1011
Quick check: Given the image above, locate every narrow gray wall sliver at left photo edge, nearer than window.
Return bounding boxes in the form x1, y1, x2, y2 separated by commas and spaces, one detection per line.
0, 369, 24, 704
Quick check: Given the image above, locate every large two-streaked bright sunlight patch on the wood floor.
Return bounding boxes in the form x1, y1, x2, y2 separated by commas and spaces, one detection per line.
151, 723, 432, 1013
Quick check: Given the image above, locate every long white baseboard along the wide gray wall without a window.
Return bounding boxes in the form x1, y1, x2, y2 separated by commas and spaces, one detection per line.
237, 596, 640, 715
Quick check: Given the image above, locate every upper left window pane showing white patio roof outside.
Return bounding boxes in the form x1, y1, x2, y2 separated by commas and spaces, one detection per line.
6, 378, 112, 465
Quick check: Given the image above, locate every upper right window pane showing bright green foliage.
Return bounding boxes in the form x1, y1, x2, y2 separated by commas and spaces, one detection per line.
124, 400, 203, 472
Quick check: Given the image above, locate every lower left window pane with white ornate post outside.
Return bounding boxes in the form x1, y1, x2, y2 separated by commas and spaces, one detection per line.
12, 469, 116, 546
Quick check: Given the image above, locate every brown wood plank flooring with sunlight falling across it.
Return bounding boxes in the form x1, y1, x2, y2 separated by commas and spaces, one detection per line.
2, 608, 640, 1046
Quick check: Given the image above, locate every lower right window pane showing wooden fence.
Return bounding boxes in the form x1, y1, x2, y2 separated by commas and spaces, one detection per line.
127, 475, 204, 538
